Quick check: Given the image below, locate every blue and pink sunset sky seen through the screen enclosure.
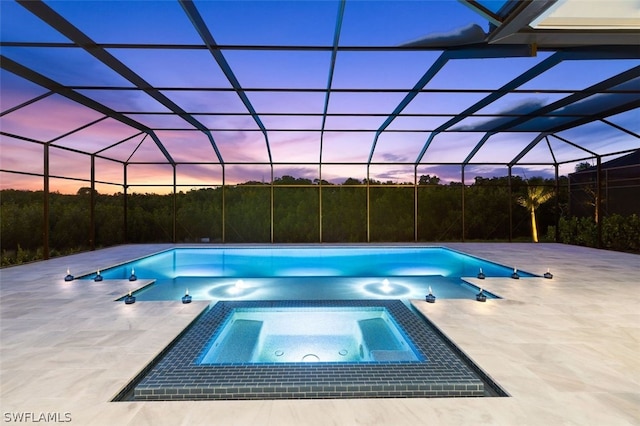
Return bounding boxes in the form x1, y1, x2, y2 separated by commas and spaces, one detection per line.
0, 0, 640, 192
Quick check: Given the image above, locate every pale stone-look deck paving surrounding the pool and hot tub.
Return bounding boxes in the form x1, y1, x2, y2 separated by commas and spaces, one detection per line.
0, 243, 640, 426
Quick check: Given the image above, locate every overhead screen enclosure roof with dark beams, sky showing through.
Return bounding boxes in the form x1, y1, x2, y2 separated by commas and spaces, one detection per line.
0, 0, 640, 183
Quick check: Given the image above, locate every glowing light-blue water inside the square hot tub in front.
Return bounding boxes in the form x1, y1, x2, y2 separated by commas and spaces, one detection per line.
199, 307, 419, 364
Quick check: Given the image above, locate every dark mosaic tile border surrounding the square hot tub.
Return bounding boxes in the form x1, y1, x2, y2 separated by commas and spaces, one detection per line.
133, 300, 485, 401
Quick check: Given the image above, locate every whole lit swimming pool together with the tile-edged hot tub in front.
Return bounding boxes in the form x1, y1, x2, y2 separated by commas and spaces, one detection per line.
104, 246, 516, 400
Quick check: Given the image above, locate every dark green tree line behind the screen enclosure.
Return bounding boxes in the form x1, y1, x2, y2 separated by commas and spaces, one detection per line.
0, 171, 608, 264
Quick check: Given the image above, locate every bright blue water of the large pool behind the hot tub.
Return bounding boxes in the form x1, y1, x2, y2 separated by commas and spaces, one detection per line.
83, 247, 534, 301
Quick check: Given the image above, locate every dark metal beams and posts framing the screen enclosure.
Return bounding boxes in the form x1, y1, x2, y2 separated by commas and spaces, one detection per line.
0, 0, 640, 258
